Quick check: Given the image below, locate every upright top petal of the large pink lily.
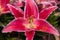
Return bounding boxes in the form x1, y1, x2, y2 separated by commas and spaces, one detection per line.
24, 0, 38, 18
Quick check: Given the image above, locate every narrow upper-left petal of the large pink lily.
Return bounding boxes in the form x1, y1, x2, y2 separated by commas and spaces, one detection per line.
7, 4, 24, 18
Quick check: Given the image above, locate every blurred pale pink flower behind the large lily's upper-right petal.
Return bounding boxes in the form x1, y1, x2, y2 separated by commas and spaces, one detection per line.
35, 0, 57, 11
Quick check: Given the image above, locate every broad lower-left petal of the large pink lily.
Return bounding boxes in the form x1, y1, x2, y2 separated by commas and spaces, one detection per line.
2, 18, 28, 33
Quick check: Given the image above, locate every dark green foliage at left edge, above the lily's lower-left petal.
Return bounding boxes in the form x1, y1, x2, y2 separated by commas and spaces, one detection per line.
0, 13, 14, 25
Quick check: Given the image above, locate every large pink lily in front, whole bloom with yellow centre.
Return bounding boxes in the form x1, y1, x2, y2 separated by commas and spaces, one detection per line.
2, 0, 59, 40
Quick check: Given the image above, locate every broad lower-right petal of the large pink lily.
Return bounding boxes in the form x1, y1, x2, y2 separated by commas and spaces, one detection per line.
35, 19, 59, 36
